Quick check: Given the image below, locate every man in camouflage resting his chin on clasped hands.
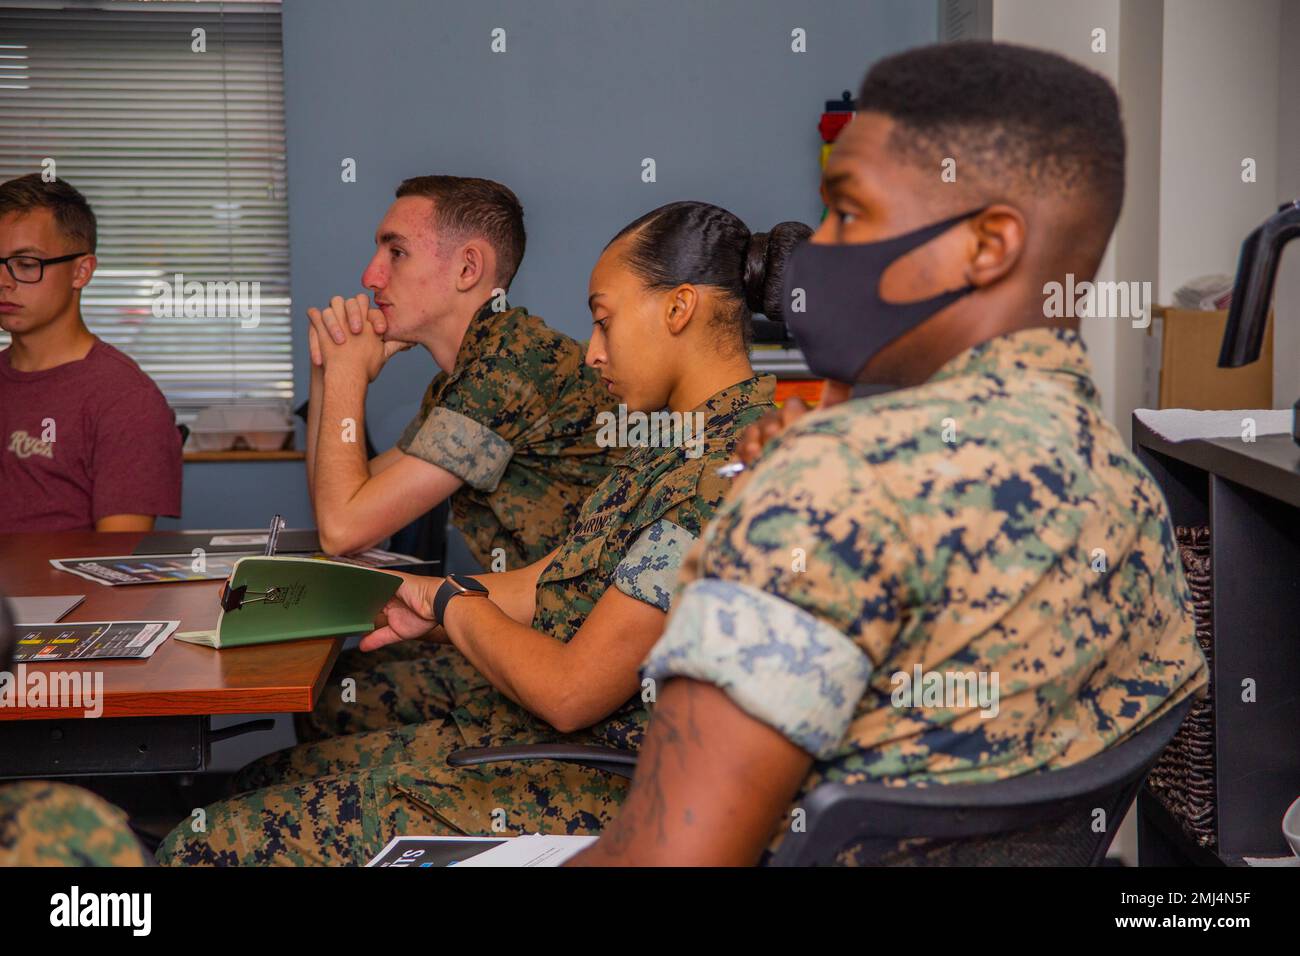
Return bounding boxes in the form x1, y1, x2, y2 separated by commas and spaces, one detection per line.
307, 176, 618, 570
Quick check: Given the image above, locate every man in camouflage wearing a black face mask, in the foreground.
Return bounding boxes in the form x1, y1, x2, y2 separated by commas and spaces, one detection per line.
575, 43, 1206, 865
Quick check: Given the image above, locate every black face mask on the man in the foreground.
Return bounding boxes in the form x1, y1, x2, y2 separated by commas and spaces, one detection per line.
785, 208, 983, 382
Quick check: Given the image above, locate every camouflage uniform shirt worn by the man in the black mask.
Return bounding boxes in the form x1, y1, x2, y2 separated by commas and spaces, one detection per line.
644, 329, 1208, 847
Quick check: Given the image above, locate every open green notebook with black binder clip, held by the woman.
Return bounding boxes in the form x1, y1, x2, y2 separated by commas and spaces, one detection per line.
173, 555, 402, 648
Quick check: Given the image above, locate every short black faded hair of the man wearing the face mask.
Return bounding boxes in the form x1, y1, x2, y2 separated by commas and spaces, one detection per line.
858, 40, 1125, 235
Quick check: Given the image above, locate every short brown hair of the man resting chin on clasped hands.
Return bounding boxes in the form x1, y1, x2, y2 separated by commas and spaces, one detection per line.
397, 176, 527, 289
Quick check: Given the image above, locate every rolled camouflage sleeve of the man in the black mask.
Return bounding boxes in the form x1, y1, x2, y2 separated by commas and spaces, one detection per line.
642, 434, 906, 760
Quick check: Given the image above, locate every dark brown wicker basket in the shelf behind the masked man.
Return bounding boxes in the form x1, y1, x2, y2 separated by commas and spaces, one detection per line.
1147, 528, 1218, 848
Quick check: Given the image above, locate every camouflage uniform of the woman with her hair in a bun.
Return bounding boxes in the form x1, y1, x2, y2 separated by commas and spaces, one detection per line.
159, 376, 775, 864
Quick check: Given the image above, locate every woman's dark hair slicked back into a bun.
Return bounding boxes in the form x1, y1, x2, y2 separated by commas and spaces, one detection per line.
606, 202, 813, 349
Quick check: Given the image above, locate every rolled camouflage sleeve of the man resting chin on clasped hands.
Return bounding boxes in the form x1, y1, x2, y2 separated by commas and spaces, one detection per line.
398, 358, 546, 493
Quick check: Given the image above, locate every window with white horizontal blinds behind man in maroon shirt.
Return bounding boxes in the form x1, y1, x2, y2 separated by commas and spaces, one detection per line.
0, 0, 293, 420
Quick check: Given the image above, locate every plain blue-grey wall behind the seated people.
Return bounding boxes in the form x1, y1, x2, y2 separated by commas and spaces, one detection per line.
172, 0, 937, 528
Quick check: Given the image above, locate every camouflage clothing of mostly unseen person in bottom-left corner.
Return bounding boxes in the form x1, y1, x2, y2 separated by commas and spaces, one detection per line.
0, 780, 151, 866
